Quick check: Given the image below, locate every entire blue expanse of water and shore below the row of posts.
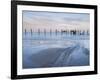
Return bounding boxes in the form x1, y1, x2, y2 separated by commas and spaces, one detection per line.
23, 34, 89, 68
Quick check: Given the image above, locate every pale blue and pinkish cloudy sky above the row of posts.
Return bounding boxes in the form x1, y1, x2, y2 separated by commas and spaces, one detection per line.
23, 11, 90, 32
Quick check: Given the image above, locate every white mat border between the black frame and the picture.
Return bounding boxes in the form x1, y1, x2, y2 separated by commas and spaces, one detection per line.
17, 5, 94, 75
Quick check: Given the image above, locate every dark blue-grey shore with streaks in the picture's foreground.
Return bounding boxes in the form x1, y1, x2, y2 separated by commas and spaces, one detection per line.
23, 46, 89, 68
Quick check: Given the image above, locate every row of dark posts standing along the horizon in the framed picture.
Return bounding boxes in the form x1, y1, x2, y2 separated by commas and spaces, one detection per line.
24, 29, 89, 35
